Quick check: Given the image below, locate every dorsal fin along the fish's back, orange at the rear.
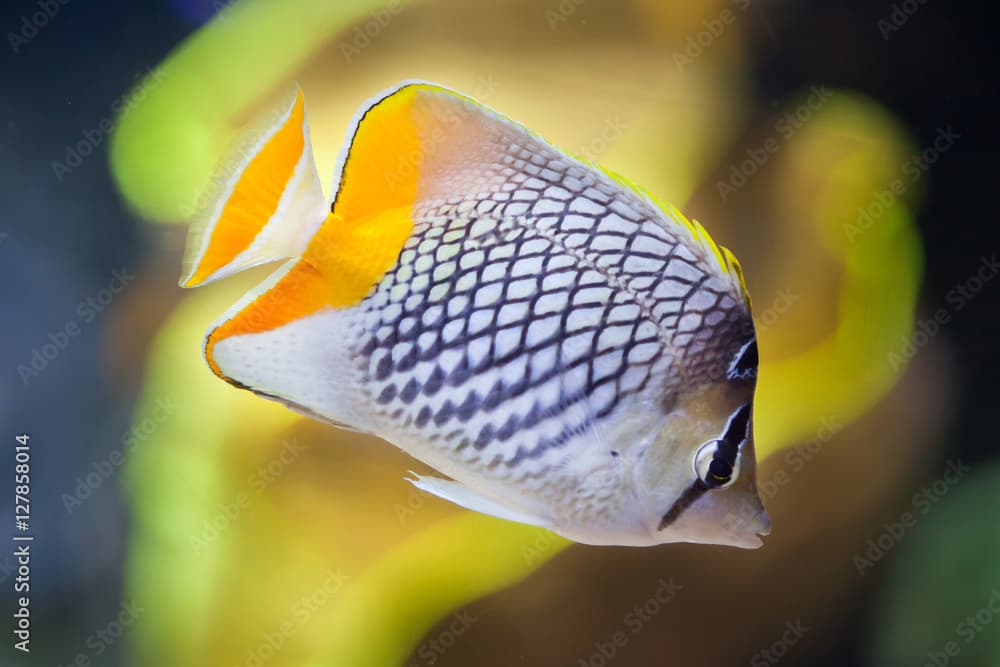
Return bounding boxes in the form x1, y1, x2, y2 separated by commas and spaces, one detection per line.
333, 81, 746, 295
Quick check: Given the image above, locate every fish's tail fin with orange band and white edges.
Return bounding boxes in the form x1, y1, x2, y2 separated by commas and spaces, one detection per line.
180, 88, 329, 287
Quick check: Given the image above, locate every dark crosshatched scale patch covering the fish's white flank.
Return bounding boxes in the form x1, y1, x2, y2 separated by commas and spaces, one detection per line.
346, 145, 752, 488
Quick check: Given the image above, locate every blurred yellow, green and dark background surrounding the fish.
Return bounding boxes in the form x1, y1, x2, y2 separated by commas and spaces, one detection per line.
0, 0, 1000, 667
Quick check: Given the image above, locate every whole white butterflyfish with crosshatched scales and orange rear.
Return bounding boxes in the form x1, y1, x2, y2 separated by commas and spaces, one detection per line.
180, 81, 770, 548
